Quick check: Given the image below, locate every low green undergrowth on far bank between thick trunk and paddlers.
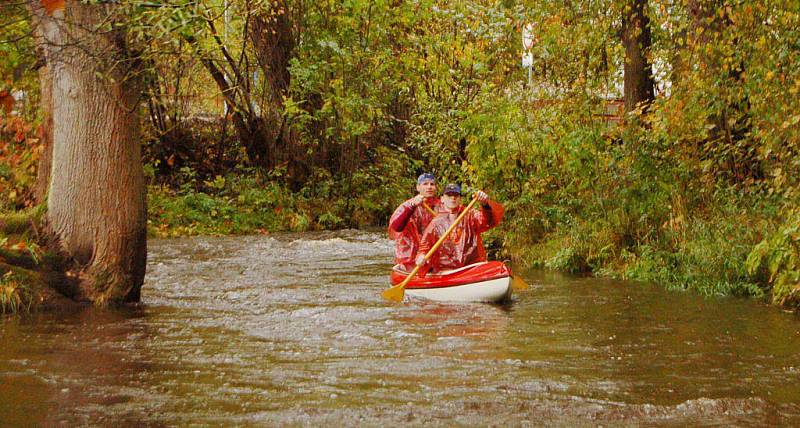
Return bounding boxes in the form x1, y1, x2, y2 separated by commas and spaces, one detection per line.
148, 145, 413, 237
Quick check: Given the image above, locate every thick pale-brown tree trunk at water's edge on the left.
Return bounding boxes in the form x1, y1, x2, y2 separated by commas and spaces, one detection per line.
31, 0, 147, 304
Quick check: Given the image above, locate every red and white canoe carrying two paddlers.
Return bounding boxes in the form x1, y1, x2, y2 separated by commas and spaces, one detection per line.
389, 261, 511, 302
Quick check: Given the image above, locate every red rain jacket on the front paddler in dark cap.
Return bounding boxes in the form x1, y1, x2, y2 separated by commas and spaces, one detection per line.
419, 200, 505, 271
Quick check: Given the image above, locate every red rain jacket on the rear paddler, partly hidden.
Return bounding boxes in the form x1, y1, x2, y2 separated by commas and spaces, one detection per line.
389, 197, 444, 270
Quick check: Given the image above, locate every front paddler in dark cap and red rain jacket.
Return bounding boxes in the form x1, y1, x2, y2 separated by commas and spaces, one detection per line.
415, 184, 505, 271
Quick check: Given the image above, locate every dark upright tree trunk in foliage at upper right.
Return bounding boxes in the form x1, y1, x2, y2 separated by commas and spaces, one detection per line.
622, 0, 655, 113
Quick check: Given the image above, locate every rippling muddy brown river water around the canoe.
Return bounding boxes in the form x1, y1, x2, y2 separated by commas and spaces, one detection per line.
0, 231, 800, 426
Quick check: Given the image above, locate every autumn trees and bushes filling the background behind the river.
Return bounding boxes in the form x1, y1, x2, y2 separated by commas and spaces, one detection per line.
0, 0, 800, 306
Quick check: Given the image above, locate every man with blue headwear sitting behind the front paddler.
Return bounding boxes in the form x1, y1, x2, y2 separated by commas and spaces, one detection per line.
389, 173, 444, 271
